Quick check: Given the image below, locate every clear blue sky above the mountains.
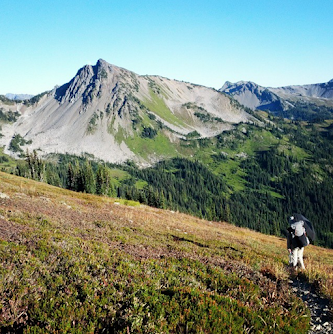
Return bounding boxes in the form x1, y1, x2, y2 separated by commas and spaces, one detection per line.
0, 0, 333, 94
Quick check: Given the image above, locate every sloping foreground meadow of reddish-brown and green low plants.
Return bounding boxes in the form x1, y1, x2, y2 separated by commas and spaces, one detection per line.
0, 172, 333, 333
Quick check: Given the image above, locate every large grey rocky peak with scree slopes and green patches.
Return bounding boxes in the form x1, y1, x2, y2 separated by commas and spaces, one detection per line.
0, 59, 255, 163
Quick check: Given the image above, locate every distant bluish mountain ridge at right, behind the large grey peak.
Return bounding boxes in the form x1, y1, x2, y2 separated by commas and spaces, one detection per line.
220, 80, 333, 119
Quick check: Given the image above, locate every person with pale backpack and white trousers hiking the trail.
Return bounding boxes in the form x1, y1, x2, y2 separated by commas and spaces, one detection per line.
287, 214, 310, 270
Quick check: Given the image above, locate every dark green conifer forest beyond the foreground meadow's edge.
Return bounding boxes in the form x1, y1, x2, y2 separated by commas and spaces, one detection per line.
8, 117, 333, 247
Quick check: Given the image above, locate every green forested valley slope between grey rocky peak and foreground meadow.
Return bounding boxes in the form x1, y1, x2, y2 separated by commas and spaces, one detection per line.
1, 112, 333, 247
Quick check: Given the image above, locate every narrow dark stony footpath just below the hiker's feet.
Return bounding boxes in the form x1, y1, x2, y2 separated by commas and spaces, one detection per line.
290, 277, 333, 334
